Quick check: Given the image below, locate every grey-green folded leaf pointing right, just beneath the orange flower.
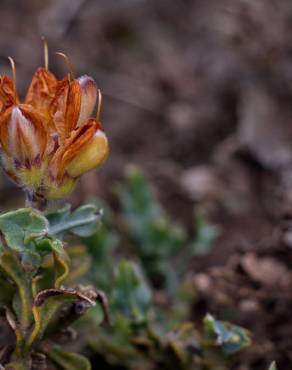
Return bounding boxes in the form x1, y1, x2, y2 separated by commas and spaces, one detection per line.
47, 204, 102, 237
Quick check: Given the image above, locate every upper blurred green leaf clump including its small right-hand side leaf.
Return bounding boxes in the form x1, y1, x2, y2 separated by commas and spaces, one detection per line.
115, 166, 218, 289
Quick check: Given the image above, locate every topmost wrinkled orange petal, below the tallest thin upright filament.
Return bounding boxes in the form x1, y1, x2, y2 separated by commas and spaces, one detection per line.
25, 68, 57, 124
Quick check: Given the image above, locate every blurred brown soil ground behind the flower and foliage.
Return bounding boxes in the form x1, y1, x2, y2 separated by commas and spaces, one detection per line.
0, 0, 292, 369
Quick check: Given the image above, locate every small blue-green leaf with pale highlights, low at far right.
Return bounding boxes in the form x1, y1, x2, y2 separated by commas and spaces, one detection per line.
204, 314, 251, 355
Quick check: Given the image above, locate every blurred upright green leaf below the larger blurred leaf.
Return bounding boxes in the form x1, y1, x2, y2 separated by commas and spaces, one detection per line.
111, 261, 151, 323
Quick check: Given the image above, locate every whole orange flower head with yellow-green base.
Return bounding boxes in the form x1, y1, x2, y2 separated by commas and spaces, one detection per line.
0, 55, 109, 199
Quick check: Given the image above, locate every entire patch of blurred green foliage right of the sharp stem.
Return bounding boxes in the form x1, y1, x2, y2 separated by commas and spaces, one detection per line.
78, 167, 249, 370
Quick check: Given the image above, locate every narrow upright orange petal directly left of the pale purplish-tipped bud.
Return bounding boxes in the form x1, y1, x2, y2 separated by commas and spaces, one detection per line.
52, 78, 81, 143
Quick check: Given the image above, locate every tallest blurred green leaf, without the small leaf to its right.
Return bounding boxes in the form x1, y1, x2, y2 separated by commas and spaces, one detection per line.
116, 166, 187, 286
